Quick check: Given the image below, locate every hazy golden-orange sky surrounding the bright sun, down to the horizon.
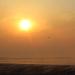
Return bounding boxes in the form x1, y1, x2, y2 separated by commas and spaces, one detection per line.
0, 0, 75, 63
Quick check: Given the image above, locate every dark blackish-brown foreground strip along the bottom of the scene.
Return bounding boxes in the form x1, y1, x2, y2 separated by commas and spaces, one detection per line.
0, 64, 75, 75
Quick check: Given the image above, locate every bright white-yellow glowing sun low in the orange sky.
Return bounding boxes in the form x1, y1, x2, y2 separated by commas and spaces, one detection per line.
19, 20, 32, 31
